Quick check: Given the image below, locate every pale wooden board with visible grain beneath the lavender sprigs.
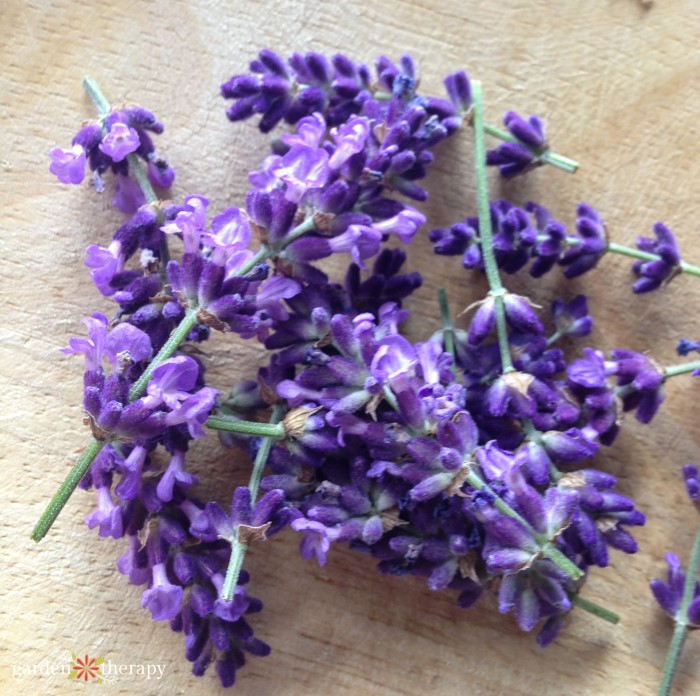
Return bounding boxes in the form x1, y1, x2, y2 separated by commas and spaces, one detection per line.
0, 0, 700, 696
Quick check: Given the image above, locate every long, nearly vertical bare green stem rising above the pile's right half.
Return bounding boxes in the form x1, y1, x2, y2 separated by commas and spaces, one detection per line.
471, 80, 514, 372
